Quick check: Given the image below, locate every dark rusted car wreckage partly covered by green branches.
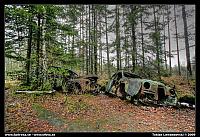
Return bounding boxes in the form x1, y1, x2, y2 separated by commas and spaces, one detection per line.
49, 66, 100, 94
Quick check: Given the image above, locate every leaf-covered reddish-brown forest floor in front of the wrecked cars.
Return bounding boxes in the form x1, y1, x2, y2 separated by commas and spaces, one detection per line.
4, 80, 195, 132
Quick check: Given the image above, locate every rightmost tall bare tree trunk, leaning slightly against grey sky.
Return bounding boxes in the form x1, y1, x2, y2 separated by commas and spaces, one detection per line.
182, 5, 192, 76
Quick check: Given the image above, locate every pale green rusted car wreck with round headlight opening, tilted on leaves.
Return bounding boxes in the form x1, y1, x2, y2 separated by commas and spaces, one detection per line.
106, 71, 177, 106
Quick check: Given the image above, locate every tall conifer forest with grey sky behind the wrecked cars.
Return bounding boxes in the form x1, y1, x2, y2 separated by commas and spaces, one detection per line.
4, 4, 195, 89
